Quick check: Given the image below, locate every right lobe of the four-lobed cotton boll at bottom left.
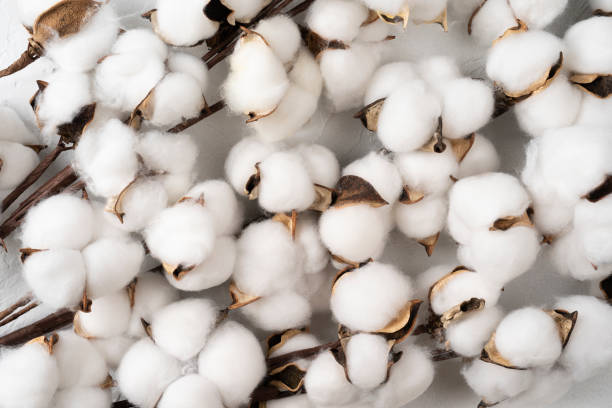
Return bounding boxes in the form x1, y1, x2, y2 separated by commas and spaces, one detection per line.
198, 322, 266, 408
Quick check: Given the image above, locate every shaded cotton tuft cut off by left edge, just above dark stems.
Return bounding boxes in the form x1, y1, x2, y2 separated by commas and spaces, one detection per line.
0, 140, 40, 190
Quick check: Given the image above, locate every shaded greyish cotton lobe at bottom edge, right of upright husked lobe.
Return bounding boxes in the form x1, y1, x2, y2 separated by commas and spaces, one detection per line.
374, 343, 434, 408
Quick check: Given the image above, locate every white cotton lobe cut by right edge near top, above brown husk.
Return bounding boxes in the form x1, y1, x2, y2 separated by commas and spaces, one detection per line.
563, 17, 612, 74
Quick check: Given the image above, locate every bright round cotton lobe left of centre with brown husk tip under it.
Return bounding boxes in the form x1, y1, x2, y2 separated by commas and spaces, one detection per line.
144, 201, 215, 266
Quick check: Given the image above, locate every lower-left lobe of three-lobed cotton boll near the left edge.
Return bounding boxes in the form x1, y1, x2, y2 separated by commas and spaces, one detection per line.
23, 249, 85, 308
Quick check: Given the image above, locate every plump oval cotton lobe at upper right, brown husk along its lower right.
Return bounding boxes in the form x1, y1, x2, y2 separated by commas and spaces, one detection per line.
487, 30, 563, 93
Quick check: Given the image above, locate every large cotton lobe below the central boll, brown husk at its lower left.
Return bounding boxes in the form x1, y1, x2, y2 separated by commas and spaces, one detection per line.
234, 219, 300, 296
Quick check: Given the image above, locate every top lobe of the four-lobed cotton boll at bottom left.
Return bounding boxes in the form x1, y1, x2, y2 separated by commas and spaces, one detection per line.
150, 299, 217, 361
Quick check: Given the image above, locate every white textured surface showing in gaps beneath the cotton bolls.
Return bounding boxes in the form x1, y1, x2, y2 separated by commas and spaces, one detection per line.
0, 0, 612, 408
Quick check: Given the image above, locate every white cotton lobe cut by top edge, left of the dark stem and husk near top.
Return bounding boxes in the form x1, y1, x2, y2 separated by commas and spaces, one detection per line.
155, 0, 219, 46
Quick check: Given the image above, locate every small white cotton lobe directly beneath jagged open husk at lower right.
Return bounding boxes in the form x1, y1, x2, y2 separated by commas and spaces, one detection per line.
446, 305, 503, 357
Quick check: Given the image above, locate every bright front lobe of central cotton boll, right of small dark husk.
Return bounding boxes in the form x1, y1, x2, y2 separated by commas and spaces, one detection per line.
258, 152, 315, 213
